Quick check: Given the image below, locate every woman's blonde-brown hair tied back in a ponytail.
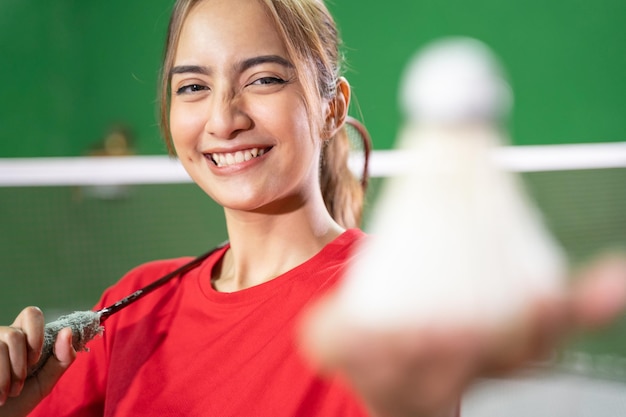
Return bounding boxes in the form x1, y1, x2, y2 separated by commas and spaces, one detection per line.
160, 0, 365, 228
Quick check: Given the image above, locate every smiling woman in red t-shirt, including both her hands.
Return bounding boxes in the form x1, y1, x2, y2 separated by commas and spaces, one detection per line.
0, 0, 624, 417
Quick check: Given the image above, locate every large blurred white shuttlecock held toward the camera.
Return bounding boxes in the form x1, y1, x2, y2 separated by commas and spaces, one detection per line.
338, 39, 567, 328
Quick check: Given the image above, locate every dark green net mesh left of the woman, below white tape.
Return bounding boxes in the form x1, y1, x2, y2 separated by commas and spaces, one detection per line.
0, 183, 226, 323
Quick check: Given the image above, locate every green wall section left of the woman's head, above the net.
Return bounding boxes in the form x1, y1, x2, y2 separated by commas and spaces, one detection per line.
0, 0, 171, 157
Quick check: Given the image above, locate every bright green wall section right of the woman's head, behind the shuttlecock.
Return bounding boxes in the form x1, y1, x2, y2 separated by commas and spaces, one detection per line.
333, 0, 626, 147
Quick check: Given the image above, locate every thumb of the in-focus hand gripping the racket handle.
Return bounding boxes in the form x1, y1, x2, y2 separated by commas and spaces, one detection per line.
0, 328, 76, 417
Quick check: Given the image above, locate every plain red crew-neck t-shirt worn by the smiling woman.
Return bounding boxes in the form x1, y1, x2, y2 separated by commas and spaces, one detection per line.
33, 230, 367, 417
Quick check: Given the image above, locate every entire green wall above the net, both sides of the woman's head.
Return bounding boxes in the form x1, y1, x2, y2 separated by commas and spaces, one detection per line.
0, 0, 626, 157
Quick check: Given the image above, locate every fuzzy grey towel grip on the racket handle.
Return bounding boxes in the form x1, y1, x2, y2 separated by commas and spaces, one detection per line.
28, 311, 104, 378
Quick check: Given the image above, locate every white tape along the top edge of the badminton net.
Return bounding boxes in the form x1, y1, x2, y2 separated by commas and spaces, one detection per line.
0, 142, 626, 187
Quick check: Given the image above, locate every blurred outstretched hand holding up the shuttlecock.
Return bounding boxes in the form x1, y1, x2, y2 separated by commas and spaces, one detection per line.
302, 257, 626, 417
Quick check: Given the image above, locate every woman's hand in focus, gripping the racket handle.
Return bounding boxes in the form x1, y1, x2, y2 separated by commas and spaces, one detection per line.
0, 307, 76, 417
